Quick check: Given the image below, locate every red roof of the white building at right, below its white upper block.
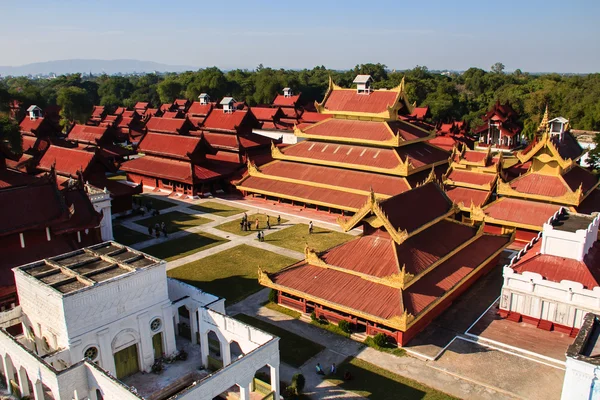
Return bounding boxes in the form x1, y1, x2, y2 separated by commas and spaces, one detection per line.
512, 240, 600, 290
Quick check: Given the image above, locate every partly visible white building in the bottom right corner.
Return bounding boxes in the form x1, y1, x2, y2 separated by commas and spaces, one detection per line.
561, 313, 600, 400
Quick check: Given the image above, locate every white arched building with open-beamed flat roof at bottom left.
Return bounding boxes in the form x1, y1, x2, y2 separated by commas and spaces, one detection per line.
0, 242, 280, 400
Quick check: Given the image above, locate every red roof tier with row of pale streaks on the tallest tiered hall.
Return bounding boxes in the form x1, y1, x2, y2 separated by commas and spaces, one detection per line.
282, 140, 400, 169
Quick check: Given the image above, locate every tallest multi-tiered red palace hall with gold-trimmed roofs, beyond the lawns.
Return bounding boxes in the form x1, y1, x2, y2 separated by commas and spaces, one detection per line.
237, 76, 449, 213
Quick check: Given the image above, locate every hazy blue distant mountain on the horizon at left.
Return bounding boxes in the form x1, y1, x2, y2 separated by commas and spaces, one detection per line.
0, 59, 198, 76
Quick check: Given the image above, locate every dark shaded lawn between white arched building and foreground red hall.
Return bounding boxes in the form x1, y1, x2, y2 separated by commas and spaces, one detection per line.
234, 314, 325, 368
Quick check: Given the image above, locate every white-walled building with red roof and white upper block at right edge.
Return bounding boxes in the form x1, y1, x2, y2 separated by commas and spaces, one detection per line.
500, 209, 600, 335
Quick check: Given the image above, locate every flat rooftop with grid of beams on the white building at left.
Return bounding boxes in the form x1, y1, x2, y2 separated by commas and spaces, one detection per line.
16, 242, 161, 294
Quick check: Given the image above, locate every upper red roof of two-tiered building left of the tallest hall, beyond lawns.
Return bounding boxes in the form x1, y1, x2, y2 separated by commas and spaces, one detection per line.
138, 132, 201, 161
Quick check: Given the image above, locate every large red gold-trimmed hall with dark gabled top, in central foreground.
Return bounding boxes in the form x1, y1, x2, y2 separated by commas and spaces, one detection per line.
259, 183, 512, 346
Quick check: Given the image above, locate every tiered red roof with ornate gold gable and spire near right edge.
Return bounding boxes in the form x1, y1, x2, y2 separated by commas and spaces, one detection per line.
471, 132, 600, 231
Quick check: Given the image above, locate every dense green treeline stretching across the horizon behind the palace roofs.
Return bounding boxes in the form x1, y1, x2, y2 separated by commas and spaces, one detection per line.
0, 63, 600, 145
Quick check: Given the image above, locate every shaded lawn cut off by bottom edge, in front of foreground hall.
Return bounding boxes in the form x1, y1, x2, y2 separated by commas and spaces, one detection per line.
328, 358, 456, 400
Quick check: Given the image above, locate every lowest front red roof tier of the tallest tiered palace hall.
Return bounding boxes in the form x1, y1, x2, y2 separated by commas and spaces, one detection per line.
239, 176, 366, 210
